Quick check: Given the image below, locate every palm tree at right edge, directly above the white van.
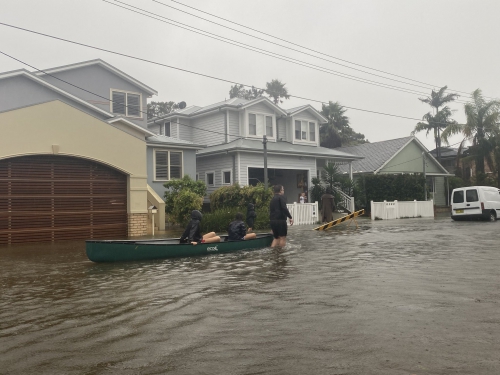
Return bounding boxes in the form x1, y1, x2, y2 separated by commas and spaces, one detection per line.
442, 89, 500, 176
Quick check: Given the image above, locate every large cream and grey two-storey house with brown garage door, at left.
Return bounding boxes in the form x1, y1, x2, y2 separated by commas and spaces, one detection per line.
0, 60, 203, 244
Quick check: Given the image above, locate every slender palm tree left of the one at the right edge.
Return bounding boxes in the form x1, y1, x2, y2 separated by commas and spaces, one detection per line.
412, 86, 459, 162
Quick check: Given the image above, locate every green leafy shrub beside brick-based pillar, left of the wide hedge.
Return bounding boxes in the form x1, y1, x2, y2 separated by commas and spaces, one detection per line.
163, 175, 207, 224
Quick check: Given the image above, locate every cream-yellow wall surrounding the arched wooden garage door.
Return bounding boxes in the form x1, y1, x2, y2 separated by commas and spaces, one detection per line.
0, 100, 147, 213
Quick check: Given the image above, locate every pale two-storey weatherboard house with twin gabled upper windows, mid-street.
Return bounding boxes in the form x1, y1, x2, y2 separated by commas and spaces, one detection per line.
148, 97, 362, 203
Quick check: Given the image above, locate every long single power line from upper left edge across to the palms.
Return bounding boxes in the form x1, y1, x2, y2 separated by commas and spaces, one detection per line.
0, 22, 468, 125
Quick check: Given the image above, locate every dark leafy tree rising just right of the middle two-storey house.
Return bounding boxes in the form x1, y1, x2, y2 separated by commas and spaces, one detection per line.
319, 101, 368, 148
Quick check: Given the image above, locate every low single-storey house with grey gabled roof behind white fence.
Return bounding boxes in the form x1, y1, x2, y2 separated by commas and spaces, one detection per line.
336, 137, 454, 206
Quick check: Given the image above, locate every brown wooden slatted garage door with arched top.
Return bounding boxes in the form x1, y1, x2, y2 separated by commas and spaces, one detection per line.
0, 155, 127, 244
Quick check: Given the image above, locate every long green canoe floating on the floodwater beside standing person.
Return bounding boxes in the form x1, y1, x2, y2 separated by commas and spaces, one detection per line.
85, 233, 273, 262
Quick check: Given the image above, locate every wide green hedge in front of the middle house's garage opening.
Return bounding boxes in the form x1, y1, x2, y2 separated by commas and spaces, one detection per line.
210, 184, 273, 213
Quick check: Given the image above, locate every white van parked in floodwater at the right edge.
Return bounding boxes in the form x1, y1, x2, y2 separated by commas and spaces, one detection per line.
451, 186, 500, 221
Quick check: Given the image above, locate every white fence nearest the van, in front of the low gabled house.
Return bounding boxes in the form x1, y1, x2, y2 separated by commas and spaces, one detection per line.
371, 200, 434, 220
